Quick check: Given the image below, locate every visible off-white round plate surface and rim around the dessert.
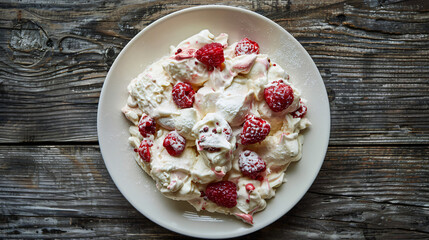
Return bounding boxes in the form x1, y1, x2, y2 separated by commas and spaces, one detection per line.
97, 6, 330, 238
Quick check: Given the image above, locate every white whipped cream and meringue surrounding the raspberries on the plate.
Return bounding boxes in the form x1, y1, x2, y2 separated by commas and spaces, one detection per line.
122, 30, 310, 223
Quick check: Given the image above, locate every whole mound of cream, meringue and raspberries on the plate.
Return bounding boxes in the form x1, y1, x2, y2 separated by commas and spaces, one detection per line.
122, 30, 310, 224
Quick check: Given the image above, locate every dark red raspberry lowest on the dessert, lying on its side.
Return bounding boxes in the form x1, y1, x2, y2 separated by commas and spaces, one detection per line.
205, 181, 237, 208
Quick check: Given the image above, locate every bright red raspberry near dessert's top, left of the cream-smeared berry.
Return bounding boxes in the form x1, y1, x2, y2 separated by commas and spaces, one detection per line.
196, 43, 225, 67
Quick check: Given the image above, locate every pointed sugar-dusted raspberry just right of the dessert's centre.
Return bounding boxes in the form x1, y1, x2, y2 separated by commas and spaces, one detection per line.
241, 115, 271, 145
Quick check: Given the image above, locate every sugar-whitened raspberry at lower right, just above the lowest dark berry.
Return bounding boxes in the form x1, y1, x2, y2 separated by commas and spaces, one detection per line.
238, 150, 266, 179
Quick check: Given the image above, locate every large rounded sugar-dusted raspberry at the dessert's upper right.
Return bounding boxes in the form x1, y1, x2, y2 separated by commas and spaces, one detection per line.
264, 80, 293, 112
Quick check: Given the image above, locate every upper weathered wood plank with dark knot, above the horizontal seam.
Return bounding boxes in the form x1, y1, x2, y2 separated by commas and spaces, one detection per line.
0, 0, 429, 145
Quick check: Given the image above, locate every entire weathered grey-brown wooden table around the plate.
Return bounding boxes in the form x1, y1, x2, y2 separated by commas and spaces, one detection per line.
0, 0, 429, 239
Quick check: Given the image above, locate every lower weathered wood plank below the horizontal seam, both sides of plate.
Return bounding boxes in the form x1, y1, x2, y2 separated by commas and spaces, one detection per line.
0, 145, 429, 239
